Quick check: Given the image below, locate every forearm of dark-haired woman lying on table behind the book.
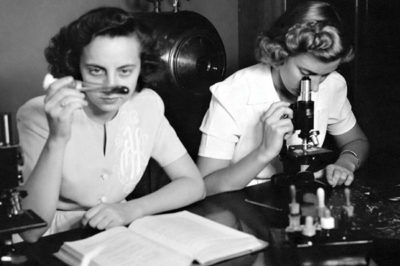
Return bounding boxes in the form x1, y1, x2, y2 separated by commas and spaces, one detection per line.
127, 177, 205, 221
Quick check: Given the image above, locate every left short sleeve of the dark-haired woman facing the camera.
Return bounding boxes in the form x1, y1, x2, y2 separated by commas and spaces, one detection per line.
17, 97, 49, 181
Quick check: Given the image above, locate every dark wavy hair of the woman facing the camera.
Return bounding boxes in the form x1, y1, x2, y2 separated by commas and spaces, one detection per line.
44, 7, 158, 90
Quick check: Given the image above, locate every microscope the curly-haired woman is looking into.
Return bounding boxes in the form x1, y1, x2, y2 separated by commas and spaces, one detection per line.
272, 76, 334, 188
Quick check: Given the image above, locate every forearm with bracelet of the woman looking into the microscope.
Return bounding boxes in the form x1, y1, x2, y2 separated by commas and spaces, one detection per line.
335, 138, 369, 172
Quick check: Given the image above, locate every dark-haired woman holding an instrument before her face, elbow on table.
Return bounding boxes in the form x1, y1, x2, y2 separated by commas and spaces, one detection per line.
17, 7, 205, 241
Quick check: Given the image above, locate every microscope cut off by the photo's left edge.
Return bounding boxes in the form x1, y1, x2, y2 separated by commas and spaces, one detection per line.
0, 113, 46, 265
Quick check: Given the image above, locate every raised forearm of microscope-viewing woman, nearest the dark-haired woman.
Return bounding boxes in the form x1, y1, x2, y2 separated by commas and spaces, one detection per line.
204, 149, 276, 195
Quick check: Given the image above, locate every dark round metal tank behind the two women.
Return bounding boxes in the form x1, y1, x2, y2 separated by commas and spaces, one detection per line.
135, 11, 226, 95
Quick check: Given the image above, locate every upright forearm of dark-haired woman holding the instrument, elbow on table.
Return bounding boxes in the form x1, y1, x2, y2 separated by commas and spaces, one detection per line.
21, 140, 65, 242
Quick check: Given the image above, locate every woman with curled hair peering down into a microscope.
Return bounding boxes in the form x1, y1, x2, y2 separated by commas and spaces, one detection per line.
198, 1, 369, 194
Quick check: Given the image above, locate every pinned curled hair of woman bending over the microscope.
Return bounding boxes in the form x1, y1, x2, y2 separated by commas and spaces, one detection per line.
255, 1, 354, 66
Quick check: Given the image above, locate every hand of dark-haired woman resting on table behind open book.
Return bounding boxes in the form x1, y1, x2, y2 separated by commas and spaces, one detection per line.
82, 203, 140, 230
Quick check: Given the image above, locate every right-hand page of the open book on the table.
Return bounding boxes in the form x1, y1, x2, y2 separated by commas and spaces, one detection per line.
129, 211, 266, 264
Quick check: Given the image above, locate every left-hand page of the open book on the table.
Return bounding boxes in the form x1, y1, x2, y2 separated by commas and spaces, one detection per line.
56, 227, 193, 266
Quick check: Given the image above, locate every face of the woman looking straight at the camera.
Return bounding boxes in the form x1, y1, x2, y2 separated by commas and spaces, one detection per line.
80, 35, 141, 115
